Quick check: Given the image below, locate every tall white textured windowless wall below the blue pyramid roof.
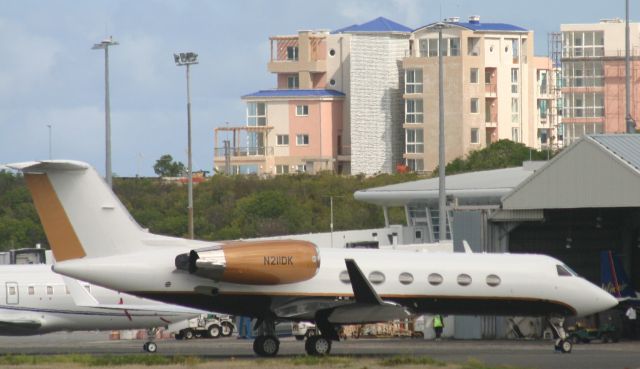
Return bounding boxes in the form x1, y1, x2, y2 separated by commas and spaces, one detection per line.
349, 34, 409, 175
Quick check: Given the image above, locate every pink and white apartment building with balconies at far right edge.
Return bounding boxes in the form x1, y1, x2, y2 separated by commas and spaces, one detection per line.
560, 19, 640, 143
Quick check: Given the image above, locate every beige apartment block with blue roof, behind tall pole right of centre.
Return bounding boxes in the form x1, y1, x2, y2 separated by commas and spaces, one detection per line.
402, 16, 553, 171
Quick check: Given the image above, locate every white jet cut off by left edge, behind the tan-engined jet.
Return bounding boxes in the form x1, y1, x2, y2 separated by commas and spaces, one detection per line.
0, 264, 202, 352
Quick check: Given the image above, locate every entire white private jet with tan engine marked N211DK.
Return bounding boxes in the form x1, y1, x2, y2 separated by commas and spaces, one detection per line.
10, 161, 617, 356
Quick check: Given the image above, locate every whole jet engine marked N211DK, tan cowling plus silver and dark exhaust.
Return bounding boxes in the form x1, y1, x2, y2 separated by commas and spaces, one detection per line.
176, 240, 320, 285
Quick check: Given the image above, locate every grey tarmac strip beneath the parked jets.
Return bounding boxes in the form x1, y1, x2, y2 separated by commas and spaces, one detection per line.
0, 332, 640, 369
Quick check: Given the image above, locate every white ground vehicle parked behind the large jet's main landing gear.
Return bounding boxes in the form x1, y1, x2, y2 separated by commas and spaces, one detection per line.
172, 314, 235, 340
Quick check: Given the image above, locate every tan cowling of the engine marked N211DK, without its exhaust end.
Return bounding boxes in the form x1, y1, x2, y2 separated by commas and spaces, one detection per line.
222, 240, 320, 285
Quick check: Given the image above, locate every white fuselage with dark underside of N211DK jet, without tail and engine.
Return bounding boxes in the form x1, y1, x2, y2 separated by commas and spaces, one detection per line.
55, 242, 616, 319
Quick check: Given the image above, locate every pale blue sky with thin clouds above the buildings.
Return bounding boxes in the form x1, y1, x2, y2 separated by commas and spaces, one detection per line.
0, 0, 640, 176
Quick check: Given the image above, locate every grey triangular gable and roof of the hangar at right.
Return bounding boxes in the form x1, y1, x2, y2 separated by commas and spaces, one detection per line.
502, 134, 640, 210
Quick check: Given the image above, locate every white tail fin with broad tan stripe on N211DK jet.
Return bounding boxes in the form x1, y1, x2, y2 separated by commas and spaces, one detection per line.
8, 160, 147, 262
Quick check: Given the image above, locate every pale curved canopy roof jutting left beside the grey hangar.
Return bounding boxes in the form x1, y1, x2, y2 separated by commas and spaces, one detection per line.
354, 162, 545, 207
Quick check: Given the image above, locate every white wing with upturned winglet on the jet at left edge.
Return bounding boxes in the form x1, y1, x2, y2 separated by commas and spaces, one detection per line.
62, 276, 207, 315
